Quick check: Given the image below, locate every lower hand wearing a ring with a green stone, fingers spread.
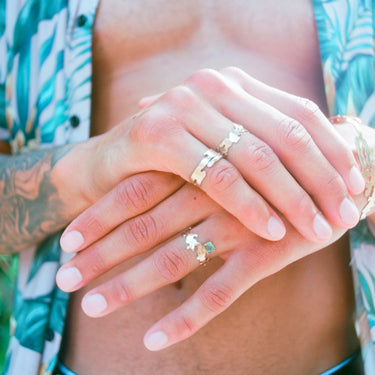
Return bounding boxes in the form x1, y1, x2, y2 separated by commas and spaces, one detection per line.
57, 172, 368, 350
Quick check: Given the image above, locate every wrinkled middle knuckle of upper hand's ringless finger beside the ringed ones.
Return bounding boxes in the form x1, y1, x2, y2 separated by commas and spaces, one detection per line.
279, 117, 311, 148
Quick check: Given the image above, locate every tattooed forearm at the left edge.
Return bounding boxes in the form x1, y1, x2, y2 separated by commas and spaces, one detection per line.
0, 145, 73, 253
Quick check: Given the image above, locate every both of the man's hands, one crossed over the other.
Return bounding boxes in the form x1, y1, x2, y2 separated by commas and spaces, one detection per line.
57, 68, 364, 350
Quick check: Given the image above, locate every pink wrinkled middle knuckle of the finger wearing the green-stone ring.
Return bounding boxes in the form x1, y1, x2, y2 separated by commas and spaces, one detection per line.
154, 247, 189, 281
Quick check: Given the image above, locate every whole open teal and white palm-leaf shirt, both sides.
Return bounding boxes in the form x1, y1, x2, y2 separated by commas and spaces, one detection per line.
0, 0, 375, 375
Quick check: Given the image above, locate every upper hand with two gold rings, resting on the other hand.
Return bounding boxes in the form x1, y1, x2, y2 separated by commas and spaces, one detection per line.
83, 68, 364, 243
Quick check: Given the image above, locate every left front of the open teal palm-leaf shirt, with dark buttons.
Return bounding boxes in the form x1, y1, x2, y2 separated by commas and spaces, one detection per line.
0, 0, 98, 375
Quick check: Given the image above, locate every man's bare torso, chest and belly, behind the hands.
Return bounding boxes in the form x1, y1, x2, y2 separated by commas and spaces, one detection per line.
63, 0, 358, 375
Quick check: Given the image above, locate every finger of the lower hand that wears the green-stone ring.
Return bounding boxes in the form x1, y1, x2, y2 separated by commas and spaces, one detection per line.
78, 214, 252, 317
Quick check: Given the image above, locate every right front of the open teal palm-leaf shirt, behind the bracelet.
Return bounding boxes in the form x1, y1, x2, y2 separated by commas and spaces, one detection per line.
313, 0, 375, 375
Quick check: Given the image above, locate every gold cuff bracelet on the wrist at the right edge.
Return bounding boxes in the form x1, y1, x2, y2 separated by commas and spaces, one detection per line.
329, 115, 375, 220
